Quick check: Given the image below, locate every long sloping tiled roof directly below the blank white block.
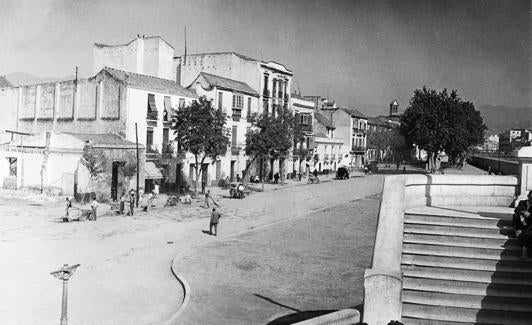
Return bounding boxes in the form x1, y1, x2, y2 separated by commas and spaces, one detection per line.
102, 67, 198, 98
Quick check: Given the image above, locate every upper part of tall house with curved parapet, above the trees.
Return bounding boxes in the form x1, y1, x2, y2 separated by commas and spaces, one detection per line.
174, 52, 293, 118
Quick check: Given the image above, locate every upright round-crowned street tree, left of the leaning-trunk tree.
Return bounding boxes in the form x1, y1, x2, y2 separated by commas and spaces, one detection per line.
174, 96, 230, 195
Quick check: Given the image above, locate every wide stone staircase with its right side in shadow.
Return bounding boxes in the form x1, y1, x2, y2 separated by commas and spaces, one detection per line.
402, 211, 532, 325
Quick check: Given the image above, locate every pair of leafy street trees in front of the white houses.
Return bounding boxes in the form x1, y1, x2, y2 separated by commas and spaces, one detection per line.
174, 96, 303, 194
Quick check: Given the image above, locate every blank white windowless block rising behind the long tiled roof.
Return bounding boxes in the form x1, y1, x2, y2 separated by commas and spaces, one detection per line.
93, 35, 176, 81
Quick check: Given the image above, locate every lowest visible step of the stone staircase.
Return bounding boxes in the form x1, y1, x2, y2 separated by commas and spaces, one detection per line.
403, 303, 532, 325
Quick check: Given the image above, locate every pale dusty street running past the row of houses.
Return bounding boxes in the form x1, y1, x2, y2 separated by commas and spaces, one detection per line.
0, 175, 383, 325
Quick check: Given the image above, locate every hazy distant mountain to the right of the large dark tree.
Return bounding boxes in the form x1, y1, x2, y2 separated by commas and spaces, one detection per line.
476, 105, 532, 134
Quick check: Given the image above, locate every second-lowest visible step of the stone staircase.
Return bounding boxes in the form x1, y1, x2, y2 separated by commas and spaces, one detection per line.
403, 290, 532, 312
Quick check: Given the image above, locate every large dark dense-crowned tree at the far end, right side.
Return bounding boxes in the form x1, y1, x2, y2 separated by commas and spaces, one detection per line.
400, 87, 486, 166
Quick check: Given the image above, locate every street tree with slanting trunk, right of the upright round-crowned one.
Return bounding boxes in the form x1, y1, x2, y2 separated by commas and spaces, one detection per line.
244, 107, 295, 188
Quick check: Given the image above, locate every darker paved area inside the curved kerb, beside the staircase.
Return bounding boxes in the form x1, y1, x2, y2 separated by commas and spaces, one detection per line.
175, 191, 380, 325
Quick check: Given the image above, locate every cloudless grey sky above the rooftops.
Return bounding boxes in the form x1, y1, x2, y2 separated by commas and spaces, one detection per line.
0, 0, 532, 115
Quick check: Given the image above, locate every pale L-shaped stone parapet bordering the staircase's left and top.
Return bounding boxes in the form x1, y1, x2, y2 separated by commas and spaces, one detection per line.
364, 175, 519, 325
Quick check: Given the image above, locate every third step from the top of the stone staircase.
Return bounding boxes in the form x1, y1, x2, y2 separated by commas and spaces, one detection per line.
403, 233, 521, 250
